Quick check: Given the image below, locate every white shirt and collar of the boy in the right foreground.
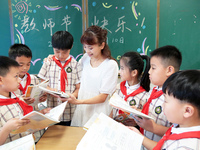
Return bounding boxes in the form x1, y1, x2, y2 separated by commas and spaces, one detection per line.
162, 126, 200, 150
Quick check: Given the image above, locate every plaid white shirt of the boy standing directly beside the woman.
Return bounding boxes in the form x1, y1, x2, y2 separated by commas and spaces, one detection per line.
38, 57, 81, 121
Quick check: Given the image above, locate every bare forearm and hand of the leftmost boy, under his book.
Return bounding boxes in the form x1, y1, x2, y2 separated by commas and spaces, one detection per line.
0, 118, 30, 145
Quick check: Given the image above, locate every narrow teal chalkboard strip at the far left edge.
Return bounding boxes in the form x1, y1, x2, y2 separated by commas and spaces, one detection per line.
0, 0, 11, 53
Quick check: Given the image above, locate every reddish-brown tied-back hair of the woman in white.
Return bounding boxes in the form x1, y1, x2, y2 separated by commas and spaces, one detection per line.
81, 25, 112, 59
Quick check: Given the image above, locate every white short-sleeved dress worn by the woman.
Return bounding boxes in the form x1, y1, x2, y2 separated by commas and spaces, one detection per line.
71, 53, 118, 126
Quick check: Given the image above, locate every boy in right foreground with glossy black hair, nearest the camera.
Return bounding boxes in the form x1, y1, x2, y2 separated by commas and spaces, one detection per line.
131, 70, 200, 150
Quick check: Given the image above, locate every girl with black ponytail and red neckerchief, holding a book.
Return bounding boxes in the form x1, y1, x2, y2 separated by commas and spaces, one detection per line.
111, 52, 150, 126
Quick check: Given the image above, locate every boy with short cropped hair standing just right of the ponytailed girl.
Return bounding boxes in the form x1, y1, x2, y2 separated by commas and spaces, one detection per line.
136, 45, 182, 141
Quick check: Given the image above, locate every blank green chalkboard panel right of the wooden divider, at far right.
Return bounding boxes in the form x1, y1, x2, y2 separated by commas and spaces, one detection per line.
159, 0, 200, 70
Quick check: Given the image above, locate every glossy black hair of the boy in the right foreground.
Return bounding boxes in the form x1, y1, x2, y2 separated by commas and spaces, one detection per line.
163, 70, 200, 116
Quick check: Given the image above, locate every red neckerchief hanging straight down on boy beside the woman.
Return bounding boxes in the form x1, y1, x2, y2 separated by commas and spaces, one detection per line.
53, 56, 72, 92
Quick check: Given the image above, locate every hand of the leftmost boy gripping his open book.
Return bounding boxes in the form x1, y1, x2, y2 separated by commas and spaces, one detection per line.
3, 118, 30, 132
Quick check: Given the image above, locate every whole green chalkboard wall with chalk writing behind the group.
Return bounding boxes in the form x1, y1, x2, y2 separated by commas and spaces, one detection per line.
0, 0, 200, 74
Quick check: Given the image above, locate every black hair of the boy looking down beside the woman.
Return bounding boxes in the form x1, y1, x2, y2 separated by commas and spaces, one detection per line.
51, 31, 74, 50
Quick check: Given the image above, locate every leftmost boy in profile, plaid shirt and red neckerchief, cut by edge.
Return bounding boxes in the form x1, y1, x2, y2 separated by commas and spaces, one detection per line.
0, 56, 50, 143
